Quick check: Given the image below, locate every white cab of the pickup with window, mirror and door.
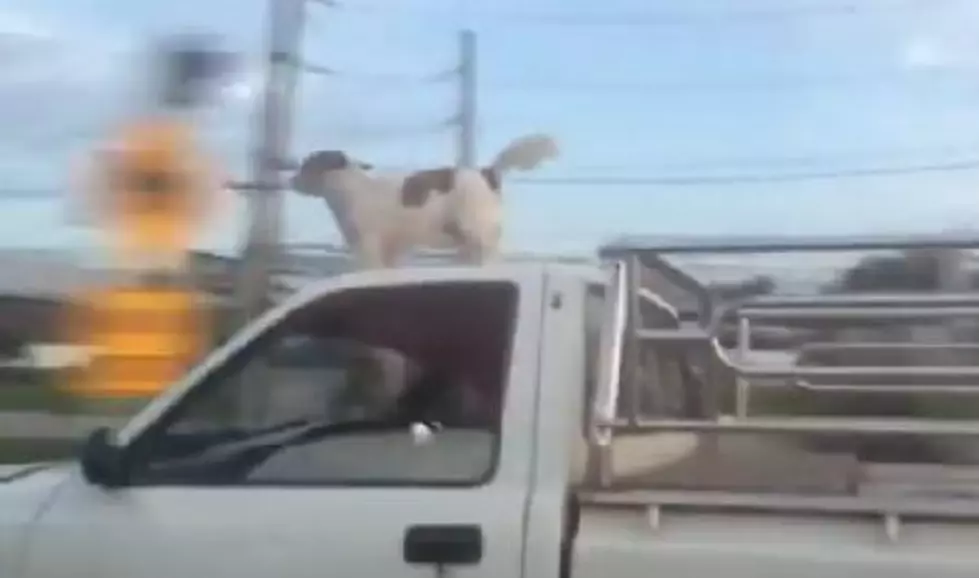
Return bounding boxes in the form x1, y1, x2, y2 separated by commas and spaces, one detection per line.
0, 265, 606, 578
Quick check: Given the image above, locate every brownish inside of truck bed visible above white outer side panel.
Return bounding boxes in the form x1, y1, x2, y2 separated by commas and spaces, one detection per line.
580, 433, 979, 501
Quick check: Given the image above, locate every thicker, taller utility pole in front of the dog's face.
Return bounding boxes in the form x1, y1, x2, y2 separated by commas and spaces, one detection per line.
235, 0, 306, 326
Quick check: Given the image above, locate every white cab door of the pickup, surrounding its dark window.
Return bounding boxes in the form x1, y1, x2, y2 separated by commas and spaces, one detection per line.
17, 269, 544, 578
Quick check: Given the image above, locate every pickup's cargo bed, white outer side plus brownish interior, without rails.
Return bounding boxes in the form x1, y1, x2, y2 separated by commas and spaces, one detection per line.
570, 434, 979, 578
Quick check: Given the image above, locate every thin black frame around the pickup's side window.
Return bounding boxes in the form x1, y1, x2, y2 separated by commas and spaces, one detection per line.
125, 279, 524, 489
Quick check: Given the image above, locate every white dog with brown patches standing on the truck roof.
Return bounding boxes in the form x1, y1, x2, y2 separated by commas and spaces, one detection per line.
291, 134, 558, 267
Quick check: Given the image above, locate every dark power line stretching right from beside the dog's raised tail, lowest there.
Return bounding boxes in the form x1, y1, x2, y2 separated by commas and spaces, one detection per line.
514, 159, 979, 187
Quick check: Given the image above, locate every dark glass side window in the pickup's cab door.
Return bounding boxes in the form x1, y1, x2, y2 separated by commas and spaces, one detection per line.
133, 282, 518, 485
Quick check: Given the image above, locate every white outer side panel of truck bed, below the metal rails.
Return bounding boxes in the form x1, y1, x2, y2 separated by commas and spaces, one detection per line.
570, 504, 979, 578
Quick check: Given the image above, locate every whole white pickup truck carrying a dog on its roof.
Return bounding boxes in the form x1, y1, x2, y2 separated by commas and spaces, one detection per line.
0, 234, 979, 578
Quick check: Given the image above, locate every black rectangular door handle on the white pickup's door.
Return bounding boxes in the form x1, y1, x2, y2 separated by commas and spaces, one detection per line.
404, 524, 483, 566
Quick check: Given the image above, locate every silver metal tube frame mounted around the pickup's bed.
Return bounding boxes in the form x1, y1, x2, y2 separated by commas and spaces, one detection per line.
590, 236, 979, 517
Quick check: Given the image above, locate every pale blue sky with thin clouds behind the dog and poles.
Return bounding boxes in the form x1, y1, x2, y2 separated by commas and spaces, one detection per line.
0, 0, 979, 270
